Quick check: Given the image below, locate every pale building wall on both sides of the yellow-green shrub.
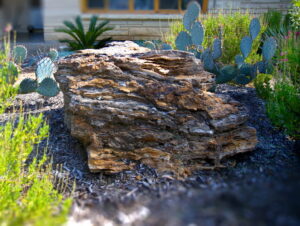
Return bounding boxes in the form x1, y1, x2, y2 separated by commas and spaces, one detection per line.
44, 0, 290, 40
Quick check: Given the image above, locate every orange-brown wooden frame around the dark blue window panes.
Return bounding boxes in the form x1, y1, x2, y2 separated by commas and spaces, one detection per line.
81, 0, 208, 14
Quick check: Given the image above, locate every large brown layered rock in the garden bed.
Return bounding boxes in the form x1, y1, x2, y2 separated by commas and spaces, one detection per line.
55, 42, 257, 174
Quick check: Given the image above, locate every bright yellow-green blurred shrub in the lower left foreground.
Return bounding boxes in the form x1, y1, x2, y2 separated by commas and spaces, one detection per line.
0, 115, 71, 226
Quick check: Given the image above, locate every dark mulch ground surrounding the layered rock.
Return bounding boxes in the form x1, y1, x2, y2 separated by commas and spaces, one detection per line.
0, 85, 300, 226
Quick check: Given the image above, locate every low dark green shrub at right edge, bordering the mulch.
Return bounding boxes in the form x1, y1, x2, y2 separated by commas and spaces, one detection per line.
266, 80, 300, 139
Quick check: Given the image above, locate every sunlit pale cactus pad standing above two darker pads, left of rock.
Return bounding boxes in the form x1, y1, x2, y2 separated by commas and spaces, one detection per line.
35, 57, 56, 83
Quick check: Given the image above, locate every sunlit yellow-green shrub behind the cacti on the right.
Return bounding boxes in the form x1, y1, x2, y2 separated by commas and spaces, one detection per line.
164, 12, 266, 64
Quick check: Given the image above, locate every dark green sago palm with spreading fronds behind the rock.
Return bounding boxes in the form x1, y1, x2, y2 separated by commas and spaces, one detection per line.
55, 16, 113, 50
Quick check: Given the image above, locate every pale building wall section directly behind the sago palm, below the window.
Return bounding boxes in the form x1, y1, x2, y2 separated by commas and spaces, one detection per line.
44, 0, 180, 40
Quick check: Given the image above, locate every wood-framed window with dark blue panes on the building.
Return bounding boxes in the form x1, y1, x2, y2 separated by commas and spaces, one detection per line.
81, 0, 208, 13
